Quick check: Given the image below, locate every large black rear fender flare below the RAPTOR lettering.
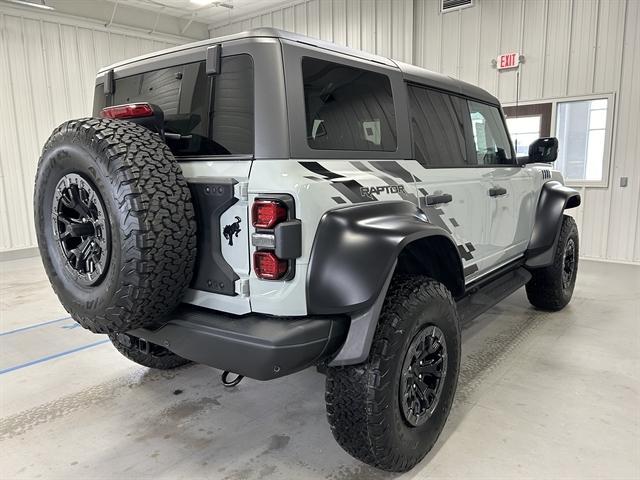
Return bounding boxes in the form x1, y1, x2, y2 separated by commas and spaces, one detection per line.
307, 201, 464, 366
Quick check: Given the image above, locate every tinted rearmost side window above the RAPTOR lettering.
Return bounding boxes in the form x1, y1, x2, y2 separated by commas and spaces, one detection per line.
302, 57, 397, 152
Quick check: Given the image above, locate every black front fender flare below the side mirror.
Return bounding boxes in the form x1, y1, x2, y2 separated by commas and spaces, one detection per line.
525, 180, 581, 268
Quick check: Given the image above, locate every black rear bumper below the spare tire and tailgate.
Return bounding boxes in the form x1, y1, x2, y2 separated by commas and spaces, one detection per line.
128, 305, 349, 380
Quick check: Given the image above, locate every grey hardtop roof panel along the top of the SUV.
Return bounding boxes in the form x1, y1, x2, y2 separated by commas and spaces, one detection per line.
98, 27, 500, 105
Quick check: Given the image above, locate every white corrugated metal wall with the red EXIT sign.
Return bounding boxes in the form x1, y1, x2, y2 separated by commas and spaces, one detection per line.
211, 0, 640, 263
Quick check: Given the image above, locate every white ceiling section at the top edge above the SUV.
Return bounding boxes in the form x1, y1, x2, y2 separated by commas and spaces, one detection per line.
109, 0, 291, 25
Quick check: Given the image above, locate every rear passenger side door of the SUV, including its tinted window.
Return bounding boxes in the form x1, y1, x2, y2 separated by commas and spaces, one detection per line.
409, 85, 491, 281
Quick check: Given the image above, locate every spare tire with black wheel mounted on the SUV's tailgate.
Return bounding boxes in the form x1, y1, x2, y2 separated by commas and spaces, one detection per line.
34, 118, 196, 333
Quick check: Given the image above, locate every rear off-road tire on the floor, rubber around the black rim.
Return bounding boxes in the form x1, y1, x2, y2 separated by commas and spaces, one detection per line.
326, 276, 460, 472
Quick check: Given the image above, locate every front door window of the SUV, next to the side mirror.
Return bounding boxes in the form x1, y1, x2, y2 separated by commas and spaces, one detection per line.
469, 101, 513, 165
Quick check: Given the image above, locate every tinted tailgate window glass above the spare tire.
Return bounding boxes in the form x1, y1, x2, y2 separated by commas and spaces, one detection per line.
112, 55, 253, 156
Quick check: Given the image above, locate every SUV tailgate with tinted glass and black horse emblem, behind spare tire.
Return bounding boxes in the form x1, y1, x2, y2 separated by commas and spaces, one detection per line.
108, 47, 254, 314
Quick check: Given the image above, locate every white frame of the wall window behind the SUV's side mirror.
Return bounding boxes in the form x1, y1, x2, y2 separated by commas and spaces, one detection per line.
504, 92, 617, 188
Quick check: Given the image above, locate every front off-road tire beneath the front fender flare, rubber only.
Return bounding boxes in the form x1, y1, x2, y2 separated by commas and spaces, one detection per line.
526, 215, 579, 311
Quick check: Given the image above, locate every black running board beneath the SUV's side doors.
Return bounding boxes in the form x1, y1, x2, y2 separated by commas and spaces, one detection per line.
456, 267, 531, 323
